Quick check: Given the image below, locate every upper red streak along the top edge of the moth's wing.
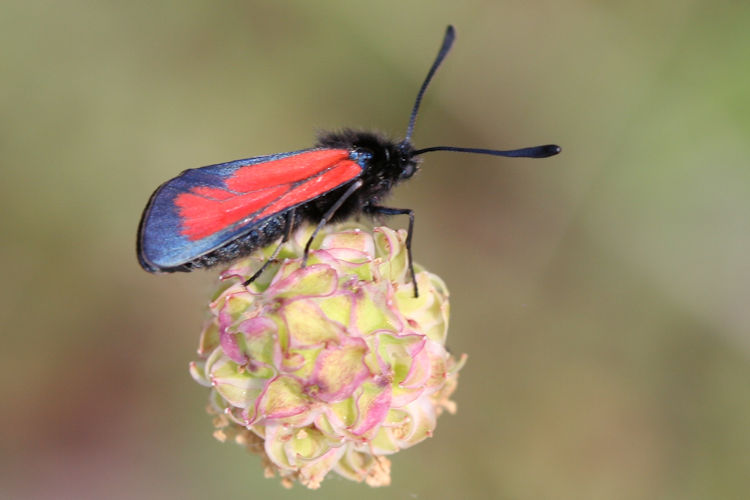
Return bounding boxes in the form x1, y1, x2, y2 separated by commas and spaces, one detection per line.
226, 149, 349, 193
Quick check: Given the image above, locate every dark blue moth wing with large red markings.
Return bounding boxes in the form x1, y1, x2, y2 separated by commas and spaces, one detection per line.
138, 149, 362, 272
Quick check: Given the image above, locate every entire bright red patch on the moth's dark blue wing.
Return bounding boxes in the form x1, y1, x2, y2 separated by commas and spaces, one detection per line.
174, 149, 362, 241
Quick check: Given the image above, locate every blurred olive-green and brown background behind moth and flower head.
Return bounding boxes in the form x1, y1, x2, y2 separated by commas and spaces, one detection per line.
0, 0, 750, 500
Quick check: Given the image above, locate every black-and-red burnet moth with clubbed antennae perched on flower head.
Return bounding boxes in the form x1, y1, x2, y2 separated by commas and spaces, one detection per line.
137, 26, 560, 297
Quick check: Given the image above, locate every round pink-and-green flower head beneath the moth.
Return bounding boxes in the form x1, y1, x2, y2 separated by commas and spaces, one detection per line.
191, 227, 464, 488
